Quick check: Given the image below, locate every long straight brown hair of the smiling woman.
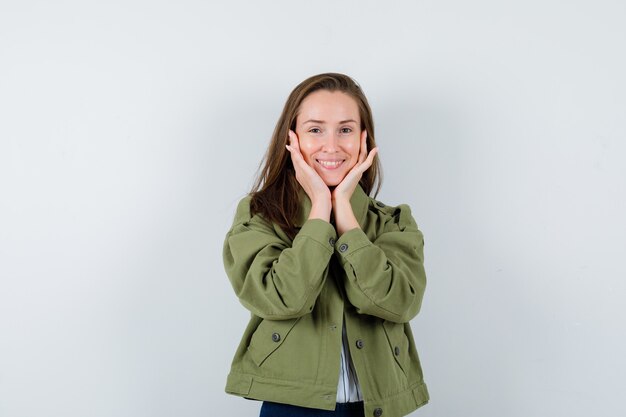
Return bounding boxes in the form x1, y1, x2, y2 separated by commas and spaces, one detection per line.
250, 73, 382, 238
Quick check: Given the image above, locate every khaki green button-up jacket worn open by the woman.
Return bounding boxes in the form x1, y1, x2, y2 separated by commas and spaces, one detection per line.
223, 186, 429, 417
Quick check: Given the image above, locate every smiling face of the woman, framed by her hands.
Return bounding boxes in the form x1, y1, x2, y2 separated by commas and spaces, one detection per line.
296, 90, 366, 187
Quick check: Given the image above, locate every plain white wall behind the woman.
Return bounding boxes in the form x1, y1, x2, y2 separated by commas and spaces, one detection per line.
0, 0, 626, 417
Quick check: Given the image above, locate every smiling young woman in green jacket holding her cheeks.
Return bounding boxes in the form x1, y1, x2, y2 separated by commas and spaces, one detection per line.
224, 73, 428, 417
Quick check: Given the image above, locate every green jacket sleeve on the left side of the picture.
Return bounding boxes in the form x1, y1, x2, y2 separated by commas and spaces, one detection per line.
223, 197, 337, 320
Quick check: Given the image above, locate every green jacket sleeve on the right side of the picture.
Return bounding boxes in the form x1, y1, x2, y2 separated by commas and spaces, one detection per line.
335, 204, 426, 323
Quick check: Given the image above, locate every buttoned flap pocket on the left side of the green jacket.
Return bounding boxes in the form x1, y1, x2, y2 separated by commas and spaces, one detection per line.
248, 317, 300, 366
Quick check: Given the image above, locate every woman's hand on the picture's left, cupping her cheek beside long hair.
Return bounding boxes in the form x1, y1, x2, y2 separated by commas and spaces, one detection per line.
286, 129, 333, 221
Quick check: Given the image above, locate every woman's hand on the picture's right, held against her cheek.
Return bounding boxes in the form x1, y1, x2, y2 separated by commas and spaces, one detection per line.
331, 130, 378, 236
